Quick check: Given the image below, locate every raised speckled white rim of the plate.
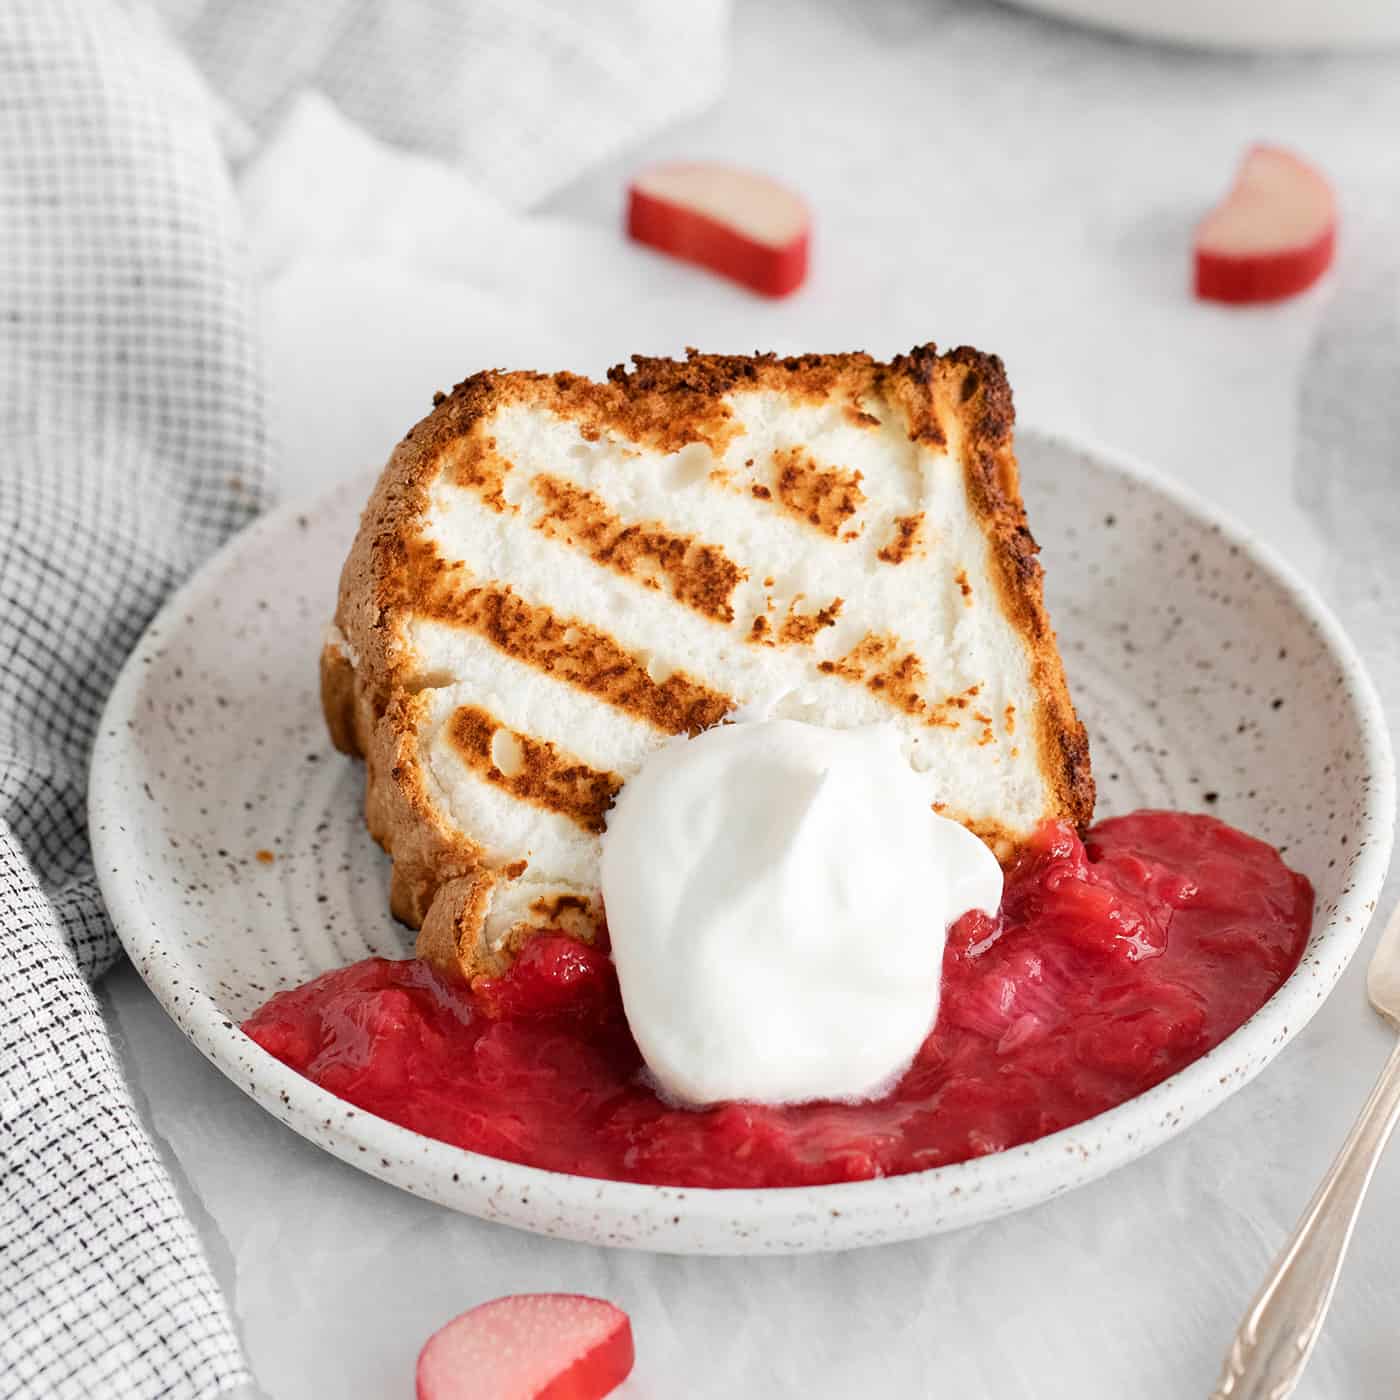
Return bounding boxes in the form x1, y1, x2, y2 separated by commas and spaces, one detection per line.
88, 430, 1394, 1254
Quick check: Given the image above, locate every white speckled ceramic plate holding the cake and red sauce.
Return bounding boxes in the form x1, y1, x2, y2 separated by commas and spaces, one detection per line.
91, 433, 1394, 1253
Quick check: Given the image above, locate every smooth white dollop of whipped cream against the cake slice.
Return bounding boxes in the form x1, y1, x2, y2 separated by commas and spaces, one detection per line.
602, 720, 1002, 1105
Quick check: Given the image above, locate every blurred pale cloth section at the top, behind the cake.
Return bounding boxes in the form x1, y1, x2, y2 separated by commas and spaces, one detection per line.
157, 0, 729, 206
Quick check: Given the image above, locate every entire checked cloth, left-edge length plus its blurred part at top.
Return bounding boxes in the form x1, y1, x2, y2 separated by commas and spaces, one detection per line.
0, 0, 728, 1397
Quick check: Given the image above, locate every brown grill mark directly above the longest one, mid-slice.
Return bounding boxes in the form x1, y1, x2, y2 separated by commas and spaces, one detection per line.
531, 475, 746, 623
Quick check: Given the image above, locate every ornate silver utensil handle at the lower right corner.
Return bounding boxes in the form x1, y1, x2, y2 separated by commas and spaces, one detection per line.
1211, 1042, 1400, 1400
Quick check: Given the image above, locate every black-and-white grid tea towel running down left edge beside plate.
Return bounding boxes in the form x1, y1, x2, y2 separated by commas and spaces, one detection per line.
0, 0, 266, 1397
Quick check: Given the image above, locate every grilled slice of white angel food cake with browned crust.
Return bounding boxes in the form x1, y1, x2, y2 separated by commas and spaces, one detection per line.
322, 346, 1093, 977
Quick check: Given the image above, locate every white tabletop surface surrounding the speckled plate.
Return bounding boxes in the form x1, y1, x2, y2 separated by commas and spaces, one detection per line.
104, 0, 1400, 1400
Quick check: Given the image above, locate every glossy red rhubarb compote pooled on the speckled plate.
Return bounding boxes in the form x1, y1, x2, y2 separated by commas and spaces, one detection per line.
244, 811, 1313, 1187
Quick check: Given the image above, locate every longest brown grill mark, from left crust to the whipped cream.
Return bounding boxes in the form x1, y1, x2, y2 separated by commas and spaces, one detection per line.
402, 539, 735, 735
